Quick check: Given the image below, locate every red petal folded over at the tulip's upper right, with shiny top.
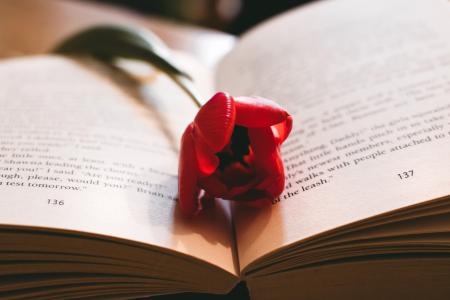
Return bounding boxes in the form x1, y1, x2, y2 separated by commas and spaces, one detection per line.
234, 96, 289, 128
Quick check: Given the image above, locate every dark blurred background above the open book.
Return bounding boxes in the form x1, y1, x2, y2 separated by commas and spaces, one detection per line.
93, 0, 311, 35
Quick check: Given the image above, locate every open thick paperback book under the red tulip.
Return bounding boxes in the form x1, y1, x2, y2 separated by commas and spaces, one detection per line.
0, 0, 450, 299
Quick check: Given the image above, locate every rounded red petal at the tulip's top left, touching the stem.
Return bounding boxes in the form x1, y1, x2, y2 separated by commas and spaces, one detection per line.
194, 93, 236, 153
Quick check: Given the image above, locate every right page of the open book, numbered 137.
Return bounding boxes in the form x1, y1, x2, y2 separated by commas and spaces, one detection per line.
217, 0, 450, 268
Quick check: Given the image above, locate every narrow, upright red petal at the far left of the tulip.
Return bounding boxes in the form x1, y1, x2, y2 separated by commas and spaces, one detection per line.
178, 123, 200, 215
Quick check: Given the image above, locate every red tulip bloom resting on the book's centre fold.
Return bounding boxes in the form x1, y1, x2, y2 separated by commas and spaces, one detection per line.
178, 93, 292, 214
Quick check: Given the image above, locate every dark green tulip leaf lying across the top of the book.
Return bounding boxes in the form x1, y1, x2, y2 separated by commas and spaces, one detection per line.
52, 25, 201, 106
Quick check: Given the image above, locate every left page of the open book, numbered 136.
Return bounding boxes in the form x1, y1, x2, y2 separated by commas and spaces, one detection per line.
0, 56, 235, 273
